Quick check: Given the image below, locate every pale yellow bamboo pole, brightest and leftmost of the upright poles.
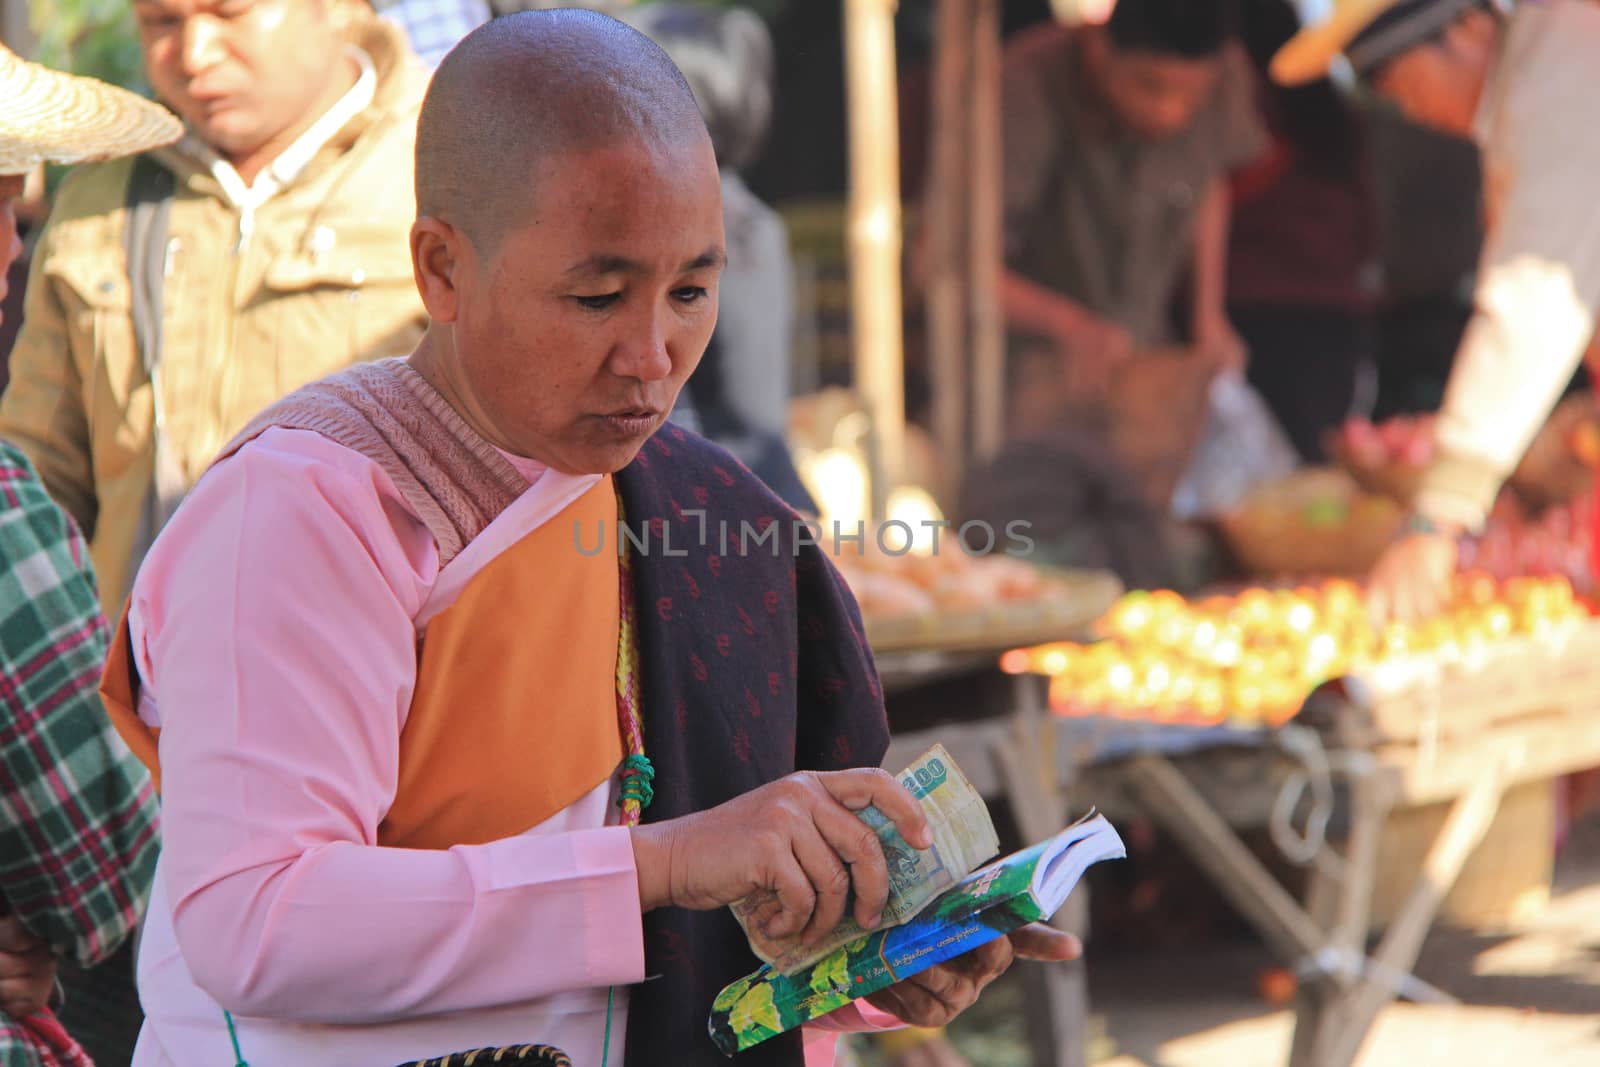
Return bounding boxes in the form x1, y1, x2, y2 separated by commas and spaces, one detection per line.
843, 0, 906, 520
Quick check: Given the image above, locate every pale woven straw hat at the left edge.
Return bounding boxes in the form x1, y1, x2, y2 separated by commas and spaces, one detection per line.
0, 45, 184, 174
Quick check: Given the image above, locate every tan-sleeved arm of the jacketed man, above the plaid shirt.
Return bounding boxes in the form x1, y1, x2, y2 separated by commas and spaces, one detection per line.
0, 224, 98, 537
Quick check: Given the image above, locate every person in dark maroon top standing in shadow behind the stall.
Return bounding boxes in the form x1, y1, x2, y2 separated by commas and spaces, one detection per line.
1227, 0, 1379, 462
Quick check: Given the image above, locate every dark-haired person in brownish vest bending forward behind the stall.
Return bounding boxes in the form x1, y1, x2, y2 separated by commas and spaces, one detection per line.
1003, 0, 1264, 396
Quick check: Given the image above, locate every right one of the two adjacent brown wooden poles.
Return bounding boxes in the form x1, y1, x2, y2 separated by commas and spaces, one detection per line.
968, 0, 1005, 459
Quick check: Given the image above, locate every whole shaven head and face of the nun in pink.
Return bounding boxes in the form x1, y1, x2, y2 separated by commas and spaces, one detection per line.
411, 10, 726, 474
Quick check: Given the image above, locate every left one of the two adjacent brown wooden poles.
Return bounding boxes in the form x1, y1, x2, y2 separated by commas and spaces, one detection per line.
923, 0, 974, 491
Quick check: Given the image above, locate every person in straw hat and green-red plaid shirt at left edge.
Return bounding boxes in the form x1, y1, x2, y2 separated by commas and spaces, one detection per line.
0, 46, 181, 1067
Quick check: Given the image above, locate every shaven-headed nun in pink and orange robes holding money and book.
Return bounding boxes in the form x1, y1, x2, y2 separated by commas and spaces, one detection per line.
104, 11, 1077, 1067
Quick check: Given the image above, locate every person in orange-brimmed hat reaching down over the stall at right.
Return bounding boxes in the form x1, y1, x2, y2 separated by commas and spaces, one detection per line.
1272, 0, 1600, 617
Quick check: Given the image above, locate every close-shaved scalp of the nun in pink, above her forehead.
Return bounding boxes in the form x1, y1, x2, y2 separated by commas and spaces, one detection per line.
416, 10, 709, 250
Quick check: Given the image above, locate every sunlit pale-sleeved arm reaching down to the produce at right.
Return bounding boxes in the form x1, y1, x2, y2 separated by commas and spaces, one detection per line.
1370, 39, 1600, 619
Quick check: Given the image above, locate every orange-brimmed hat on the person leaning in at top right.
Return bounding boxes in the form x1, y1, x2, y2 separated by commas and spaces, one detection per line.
1272, 0, 1477, 85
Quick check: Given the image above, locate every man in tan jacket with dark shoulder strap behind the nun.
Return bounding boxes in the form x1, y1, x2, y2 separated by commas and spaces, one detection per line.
0, 0, 427, 617
